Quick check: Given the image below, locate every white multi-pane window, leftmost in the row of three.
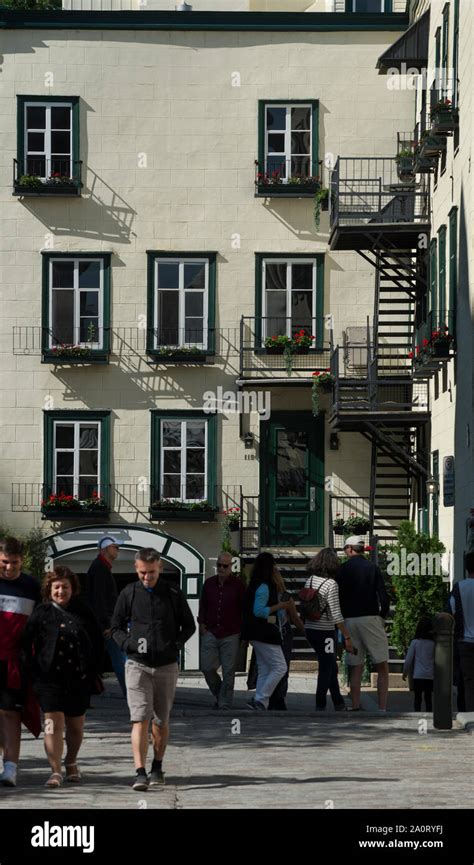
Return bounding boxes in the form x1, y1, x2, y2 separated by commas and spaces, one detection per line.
48, 257, 104, 349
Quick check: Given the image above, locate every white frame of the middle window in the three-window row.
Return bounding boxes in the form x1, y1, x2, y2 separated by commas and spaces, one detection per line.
153, 256, 209, 351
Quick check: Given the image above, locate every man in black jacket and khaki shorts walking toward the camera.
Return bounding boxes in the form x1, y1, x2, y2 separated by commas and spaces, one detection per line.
112, 548, 196, 790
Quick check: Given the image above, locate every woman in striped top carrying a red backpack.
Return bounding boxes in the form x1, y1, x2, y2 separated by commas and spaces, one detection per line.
299, 547, 352, 712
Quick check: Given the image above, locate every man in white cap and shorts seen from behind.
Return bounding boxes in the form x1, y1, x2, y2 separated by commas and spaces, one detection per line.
336, 535, 390, 712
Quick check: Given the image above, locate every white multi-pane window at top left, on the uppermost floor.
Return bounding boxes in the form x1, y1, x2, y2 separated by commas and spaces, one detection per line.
22, 100, 74, 180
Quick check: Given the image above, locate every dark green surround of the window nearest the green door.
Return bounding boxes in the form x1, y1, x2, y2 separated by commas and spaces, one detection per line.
150, 409, 218, 507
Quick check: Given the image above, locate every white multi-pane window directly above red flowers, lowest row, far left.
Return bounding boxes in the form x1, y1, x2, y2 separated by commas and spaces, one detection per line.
52, 421, 101, 501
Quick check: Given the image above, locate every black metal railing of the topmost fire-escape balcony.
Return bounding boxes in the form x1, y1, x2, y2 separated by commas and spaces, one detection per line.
330, 156, 430, 226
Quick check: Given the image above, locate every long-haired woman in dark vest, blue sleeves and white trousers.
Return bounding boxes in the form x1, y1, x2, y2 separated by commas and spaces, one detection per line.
242, 553, 292, 711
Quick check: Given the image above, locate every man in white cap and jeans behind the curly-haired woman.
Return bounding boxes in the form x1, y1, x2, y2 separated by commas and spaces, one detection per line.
86, 535, 127, 697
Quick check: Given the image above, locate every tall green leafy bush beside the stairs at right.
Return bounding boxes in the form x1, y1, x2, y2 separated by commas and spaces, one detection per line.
379, 520, 448, 654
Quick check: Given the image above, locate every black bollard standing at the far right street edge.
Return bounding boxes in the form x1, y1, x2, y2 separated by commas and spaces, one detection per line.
433, 613, 454, 730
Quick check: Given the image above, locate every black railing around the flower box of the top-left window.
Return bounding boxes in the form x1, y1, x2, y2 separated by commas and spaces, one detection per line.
13, 155, 82, 195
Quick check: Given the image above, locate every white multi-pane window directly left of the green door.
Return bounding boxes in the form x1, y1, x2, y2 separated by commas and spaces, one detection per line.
160, 418, 209, 502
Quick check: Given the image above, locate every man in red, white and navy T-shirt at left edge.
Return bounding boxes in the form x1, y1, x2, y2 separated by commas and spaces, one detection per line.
0, 538, 40, 787
